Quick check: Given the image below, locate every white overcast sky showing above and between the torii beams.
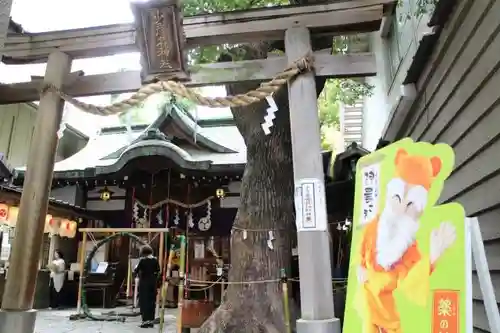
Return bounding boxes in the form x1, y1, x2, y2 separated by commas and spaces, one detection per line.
0, 0, 231, 135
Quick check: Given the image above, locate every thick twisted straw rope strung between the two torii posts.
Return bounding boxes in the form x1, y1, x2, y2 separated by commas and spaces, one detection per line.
41, 55, 313, 116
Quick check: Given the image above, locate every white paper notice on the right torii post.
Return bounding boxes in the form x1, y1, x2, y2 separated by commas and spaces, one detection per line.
295, 178, 328, 231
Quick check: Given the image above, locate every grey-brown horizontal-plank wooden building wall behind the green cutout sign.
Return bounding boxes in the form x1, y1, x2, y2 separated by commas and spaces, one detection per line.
390, 0, 500, 332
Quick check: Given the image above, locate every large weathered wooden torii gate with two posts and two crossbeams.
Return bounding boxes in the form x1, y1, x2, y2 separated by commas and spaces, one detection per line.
0, 0, 395, 333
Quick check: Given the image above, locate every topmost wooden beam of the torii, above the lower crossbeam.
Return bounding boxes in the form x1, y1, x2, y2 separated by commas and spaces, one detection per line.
3, 0, 395, 63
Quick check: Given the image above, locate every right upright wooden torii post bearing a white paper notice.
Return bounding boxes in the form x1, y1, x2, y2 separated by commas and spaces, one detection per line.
285, 27, 340, 333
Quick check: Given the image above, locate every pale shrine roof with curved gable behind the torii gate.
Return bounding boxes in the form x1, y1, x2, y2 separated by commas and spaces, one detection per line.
12, 104, 246, 179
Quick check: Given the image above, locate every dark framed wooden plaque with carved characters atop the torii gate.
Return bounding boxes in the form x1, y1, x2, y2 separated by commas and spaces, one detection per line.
132, 0, 189, 82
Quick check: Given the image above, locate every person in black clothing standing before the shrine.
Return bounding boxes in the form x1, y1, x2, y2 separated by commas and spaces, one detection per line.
134, 245, 160, 328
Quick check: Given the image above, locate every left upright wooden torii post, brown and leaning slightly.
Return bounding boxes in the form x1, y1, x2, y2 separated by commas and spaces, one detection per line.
0, 51, 71, 333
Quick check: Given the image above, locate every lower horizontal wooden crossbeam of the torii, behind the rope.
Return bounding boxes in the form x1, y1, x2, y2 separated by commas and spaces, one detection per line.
0, 53, 376, 104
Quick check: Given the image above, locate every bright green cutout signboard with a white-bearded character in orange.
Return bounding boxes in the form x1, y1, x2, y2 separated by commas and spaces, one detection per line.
343, 139, 472, 333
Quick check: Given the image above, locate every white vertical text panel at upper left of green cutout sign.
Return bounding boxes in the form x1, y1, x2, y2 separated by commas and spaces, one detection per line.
361, 163, 380, 223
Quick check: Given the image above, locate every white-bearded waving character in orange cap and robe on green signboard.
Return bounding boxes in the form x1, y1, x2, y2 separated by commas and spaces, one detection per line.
356, 149, 456, 333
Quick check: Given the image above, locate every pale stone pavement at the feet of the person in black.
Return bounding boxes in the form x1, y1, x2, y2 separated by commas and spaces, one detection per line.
35, 309, 177, 333
